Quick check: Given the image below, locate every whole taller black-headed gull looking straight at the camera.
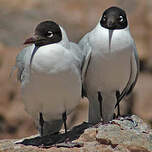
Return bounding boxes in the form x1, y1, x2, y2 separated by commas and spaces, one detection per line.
79, 7, 139, 124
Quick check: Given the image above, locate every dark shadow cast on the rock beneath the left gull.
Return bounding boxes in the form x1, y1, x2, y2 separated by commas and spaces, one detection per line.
16, 122, 92, 148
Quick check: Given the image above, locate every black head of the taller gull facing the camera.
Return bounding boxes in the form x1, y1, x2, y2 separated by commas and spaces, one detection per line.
100, 7, 128, 30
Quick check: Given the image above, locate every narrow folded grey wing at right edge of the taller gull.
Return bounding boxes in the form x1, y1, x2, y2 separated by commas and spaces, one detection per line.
115, 44, 139, 107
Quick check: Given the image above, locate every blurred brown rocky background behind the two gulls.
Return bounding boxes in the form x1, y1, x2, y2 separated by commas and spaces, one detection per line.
0, 0, 152, 139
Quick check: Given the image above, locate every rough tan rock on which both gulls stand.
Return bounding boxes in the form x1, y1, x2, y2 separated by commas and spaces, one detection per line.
0, 115, 152, 152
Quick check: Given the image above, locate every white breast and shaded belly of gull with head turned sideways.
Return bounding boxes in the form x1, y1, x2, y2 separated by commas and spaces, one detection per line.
22, 44, 81, 121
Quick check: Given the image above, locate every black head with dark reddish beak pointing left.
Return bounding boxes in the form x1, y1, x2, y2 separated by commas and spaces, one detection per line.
24, 21, 62, 46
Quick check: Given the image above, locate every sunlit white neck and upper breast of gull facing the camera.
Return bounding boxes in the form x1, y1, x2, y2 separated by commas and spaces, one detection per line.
89, 23, 133, 53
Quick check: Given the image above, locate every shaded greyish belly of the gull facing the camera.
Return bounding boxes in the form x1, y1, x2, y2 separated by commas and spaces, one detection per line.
86, 52, 131, 92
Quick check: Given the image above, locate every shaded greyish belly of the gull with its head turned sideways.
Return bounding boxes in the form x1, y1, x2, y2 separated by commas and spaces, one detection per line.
22, 71, 81, 121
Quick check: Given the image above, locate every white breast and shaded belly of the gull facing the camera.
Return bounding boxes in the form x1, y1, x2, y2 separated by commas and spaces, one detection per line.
86, 25, 133, 91
